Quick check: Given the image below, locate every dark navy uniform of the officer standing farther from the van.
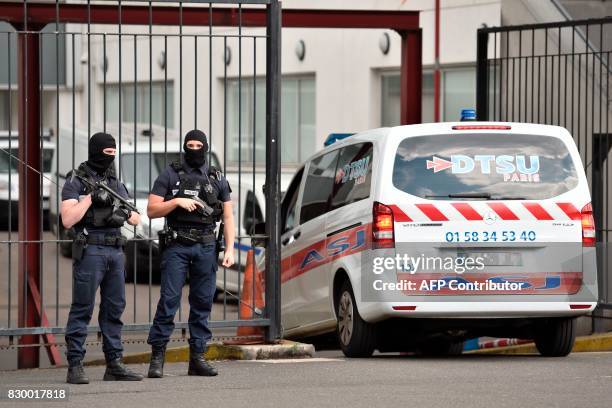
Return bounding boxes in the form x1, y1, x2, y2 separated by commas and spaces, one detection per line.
62, 163, 128, 364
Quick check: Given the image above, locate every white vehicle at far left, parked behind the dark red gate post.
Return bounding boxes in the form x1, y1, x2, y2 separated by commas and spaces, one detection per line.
0, 130, 55, 229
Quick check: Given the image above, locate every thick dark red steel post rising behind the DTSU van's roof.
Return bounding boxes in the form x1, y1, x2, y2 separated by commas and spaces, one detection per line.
400, 28, 423, 125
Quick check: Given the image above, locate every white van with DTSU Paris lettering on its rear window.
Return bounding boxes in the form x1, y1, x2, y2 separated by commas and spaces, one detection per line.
281, 122, 597, 357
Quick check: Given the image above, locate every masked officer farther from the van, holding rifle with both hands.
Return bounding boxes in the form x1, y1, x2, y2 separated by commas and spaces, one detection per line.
61, 133, 142, 384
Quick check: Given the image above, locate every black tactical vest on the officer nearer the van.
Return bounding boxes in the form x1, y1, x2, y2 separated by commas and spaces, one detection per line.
164, 162, 223, 229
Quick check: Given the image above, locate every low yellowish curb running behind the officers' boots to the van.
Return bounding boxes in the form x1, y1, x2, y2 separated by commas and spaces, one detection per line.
85, 340, 315, 366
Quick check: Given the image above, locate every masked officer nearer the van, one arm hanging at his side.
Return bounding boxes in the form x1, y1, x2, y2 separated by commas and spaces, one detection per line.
147, 130, 234, 378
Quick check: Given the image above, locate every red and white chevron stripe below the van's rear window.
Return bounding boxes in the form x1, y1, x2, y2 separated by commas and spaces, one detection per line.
389, 201, 580, 222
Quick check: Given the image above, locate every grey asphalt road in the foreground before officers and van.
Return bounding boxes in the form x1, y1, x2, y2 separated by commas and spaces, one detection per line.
0, 351, 612, 408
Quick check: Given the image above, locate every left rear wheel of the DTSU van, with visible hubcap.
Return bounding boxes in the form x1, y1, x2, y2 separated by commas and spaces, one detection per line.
336, 280, 375, 357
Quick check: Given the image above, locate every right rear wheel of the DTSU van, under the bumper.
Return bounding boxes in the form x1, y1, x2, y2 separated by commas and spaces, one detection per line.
534, 318, 576, 357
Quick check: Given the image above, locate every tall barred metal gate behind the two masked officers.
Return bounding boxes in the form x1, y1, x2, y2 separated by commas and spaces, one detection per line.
0, 0, 281, 367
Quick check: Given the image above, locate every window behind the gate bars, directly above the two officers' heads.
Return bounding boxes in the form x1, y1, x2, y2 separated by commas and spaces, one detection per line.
106, 81, 174, 128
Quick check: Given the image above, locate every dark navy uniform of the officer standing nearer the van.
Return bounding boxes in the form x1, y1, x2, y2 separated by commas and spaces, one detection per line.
147, 159, 231, 364
